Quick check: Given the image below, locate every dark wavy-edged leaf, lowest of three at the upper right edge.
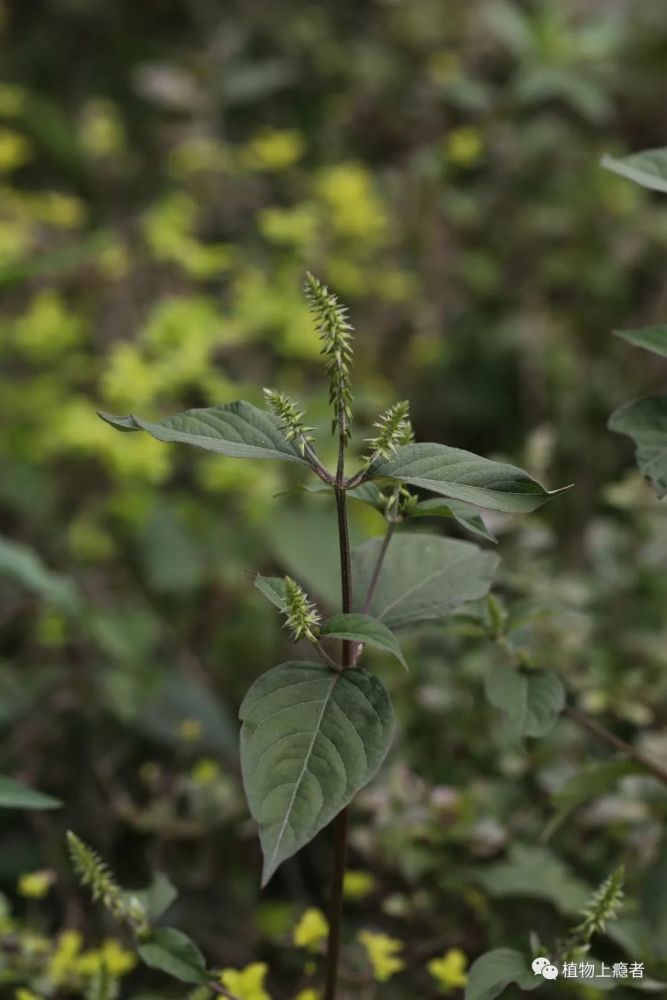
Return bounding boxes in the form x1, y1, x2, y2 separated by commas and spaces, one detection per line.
608, 396, 667, 497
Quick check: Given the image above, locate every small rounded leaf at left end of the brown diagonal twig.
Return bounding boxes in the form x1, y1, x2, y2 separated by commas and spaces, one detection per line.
484, 667, 565, 739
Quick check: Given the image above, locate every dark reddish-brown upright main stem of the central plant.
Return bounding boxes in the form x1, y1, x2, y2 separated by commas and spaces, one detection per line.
324, 417, 353, 1000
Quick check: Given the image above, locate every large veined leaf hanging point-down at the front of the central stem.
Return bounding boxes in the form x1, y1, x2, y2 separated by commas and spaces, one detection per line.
239, 662, 394, 885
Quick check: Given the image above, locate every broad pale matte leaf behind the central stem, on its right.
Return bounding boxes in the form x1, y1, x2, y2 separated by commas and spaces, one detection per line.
352, 534, 499, 628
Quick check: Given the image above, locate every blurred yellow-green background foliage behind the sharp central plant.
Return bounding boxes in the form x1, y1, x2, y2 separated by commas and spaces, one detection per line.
0, 0, 667, 1000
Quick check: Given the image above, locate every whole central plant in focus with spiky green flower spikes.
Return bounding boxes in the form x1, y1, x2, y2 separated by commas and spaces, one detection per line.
86, 274, 561, 1000
